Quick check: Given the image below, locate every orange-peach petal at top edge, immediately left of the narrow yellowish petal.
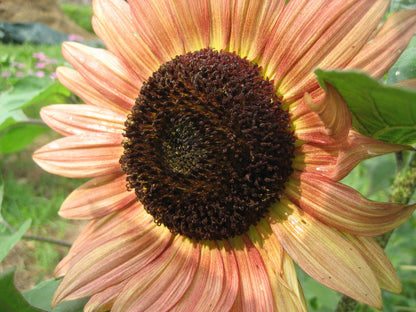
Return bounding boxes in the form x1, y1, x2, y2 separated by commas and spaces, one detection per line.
172, 0, 210, 52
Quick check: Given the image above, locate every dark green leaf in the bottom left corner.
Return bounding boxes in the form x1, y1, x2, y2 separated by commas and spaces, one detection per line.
0, 268, 43, 312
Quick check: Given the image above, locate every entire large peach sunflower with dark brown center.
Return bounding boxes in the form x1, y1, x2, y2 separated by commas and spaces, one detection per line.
34, 0, 416, 312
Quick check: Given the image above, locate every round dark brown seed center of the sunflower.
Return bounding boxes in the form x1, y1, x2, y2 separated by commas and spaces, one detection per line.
120, 49, 295, 240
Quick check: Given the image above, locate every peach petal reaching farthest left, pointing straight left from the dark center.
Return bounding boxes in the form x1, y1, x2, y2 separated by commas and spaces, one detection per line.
33, 133, 123, 178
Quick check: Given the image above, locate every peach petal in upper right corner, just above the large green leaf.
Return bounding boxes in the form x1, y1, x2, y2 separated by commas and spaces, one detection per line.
346, 10, 416, 78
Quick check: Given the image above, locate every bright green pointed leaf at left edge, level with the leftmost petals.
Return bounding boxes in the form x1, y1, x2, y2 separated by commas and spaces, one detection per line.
0, 122, 49, 153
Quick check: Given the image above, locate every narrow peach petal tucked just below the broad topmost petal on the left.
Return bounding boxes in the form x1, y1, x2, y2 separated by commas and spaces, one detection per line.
56, 66, 130, 115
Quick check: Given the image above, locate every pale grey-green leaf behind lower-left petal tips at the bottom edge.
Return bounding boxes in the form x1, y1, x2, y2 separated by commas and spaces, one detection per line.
23, 279, 89, 312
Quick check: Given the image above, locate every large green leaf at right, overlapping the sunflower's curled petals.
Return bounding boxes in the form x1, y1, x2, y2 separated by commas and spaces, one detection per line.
315, 69, 416, 145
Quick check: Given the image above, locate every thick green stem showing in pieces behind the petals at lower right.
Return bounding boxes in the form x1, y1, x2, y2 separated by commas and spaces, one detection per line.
335, 152, 416, 312
